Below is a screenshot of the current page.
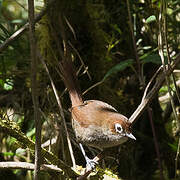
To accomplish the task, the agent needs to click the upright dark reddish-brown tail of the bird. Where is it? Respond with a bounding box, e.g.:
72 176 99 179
60 60 83 107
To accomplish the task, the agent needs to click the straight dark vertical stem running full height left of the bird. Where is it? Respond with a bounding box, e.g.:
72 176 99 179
28 0 42 180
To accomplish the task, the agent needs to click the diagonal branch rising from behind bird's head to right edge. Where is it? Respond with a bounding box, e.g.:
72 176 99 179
129 53 180 123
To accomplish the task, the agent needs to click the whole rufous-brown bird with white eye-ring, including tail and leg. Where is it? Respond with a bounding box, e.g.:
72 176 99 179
60 59 136 169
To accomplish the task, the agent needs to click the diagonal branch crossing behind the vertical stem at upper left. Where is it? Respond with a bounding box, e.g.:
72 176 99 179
0 0 56 53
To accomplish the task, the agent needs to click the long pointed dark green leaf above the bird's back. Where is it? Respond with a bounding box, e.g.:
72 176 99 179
103 59 133 81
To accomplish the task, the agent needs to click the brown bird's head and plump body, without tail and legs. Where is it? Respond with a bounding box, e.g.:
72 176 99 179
71 100 135 149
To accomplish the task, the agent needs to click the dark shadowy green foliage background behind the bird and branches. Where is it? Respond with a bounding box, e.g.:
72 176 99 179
0 0 180 180
